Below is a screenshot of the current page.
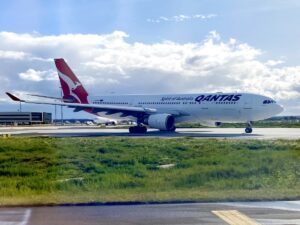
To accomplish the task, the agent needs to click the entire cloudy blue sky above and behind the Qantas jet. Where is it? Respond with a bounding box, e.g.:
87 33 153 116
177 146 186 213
0 0 300 118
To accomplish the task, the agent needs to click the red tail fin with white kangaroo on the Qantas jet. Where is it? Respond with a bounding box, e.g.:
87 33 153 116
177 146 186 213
54 59 88 103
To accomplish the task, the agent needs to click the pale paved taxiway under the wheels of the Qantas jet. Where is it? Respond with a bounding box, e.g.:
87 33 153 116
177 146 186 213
0 126 300 139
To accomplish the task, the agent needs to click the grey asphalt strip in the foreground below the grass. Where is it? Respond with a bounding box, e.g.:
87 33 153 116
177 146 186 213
0 201 300 225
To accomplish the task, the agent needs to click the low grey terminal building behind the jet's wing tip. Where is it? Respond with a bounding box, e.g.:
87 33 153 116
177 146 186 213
0 112 52 125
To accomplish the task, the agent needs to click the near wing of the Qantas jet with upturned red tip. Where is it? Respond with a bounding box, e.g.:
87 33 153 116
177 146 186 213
6 92 157 117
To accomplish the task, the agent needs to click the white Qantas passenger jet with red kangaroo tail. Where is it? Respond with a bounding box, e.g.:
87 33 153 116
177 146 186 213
6 58 283 133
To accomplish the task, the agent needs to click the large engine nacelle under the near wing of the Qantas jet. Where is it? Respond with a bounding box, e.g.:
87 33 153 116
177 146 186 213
145 113 175 130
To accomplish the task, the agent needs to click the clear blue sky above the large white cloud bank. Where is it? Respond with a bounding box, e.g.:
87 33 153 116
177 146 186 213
0 0 300 64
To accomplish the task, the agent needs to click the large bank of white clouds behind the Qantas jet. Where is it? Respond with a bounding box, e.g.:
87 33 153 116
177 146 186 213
0 31 300 114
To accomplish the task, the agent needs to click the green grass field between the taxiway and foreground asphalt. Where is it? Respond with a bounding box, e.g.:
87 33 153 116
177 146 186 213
0 137 300 205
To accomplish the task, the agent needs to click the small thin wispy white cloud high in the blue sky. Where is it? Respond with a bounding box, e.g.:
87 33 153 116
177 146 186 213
147 14 217 23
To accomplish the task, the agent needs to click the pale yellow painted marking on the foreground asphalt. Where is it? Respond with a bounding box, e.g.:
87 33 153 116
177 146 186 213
212 210 260 225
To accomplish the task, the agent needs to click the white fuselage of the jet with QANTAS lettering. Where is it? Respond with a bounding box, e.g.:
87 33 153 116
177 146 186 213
89 93 283 123
